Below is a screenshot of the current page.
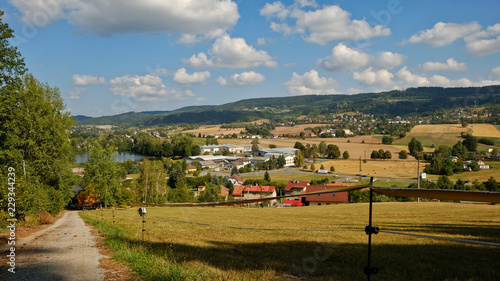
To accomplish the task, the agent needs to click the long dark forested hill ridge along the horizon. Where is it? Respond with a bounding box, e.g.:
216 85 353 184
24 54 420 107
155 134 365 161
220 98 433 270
78 86 500 126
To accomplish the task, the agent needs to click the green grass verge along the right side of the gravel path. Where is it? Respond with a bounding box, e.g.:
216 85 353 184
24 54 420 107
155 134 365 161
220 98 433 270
80 213 204 280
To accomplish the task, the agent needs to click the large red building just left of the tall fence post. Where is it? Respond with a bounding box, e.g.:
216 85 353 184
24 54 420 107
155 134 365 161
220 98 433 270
300 184 349 206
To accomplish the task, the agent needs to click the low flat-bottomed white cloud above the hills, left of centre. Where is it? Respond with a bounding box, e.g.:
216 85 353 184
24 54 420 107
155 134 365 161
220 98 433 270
109 74 193 101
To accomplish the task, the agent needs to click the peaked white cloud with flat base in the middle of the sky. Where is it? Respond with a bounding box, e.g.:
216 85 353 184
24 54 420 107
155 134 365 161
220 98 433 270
183 34 278 69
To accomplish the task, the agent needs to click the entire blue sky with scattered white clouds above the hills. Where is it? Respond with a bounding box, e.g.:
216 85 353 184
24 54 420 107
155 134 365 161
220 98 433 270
0 0 500 117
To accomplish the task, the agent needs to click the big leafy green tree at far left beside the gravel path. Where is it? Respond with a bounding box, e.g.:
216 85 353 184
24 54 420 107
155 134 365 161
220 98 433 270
0 74 77 216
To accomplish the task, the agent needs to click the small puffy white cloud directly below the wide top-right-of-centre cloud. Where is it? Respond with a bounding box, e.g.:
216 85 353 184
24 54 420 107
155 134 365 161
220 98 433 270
316 43 370 71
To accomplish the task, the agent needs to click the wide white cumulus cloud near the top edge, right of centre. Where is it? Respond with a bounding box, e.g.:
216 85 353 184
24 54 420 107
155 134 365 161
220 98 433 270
260 1 391 45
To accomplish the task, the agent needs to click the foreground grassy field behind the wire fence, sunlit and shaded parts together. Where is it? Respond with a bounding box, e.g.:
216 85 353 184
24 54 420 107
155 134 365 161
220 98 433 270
80 202 500 280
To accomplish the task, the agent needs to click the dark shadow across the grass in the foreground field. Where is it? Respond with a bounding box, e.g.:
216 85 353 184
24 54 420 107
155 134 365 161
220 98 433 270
115 236 500 280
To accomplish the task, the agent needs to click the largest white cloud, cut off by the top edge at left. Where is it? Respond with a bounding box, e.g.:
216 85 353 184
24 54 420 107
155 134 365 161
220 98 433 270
10 0 240 43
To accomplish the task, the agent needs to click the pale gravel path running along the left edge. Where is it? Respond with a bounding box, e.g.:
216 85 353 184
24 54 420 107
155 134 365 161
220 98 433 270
0 211 105 281
